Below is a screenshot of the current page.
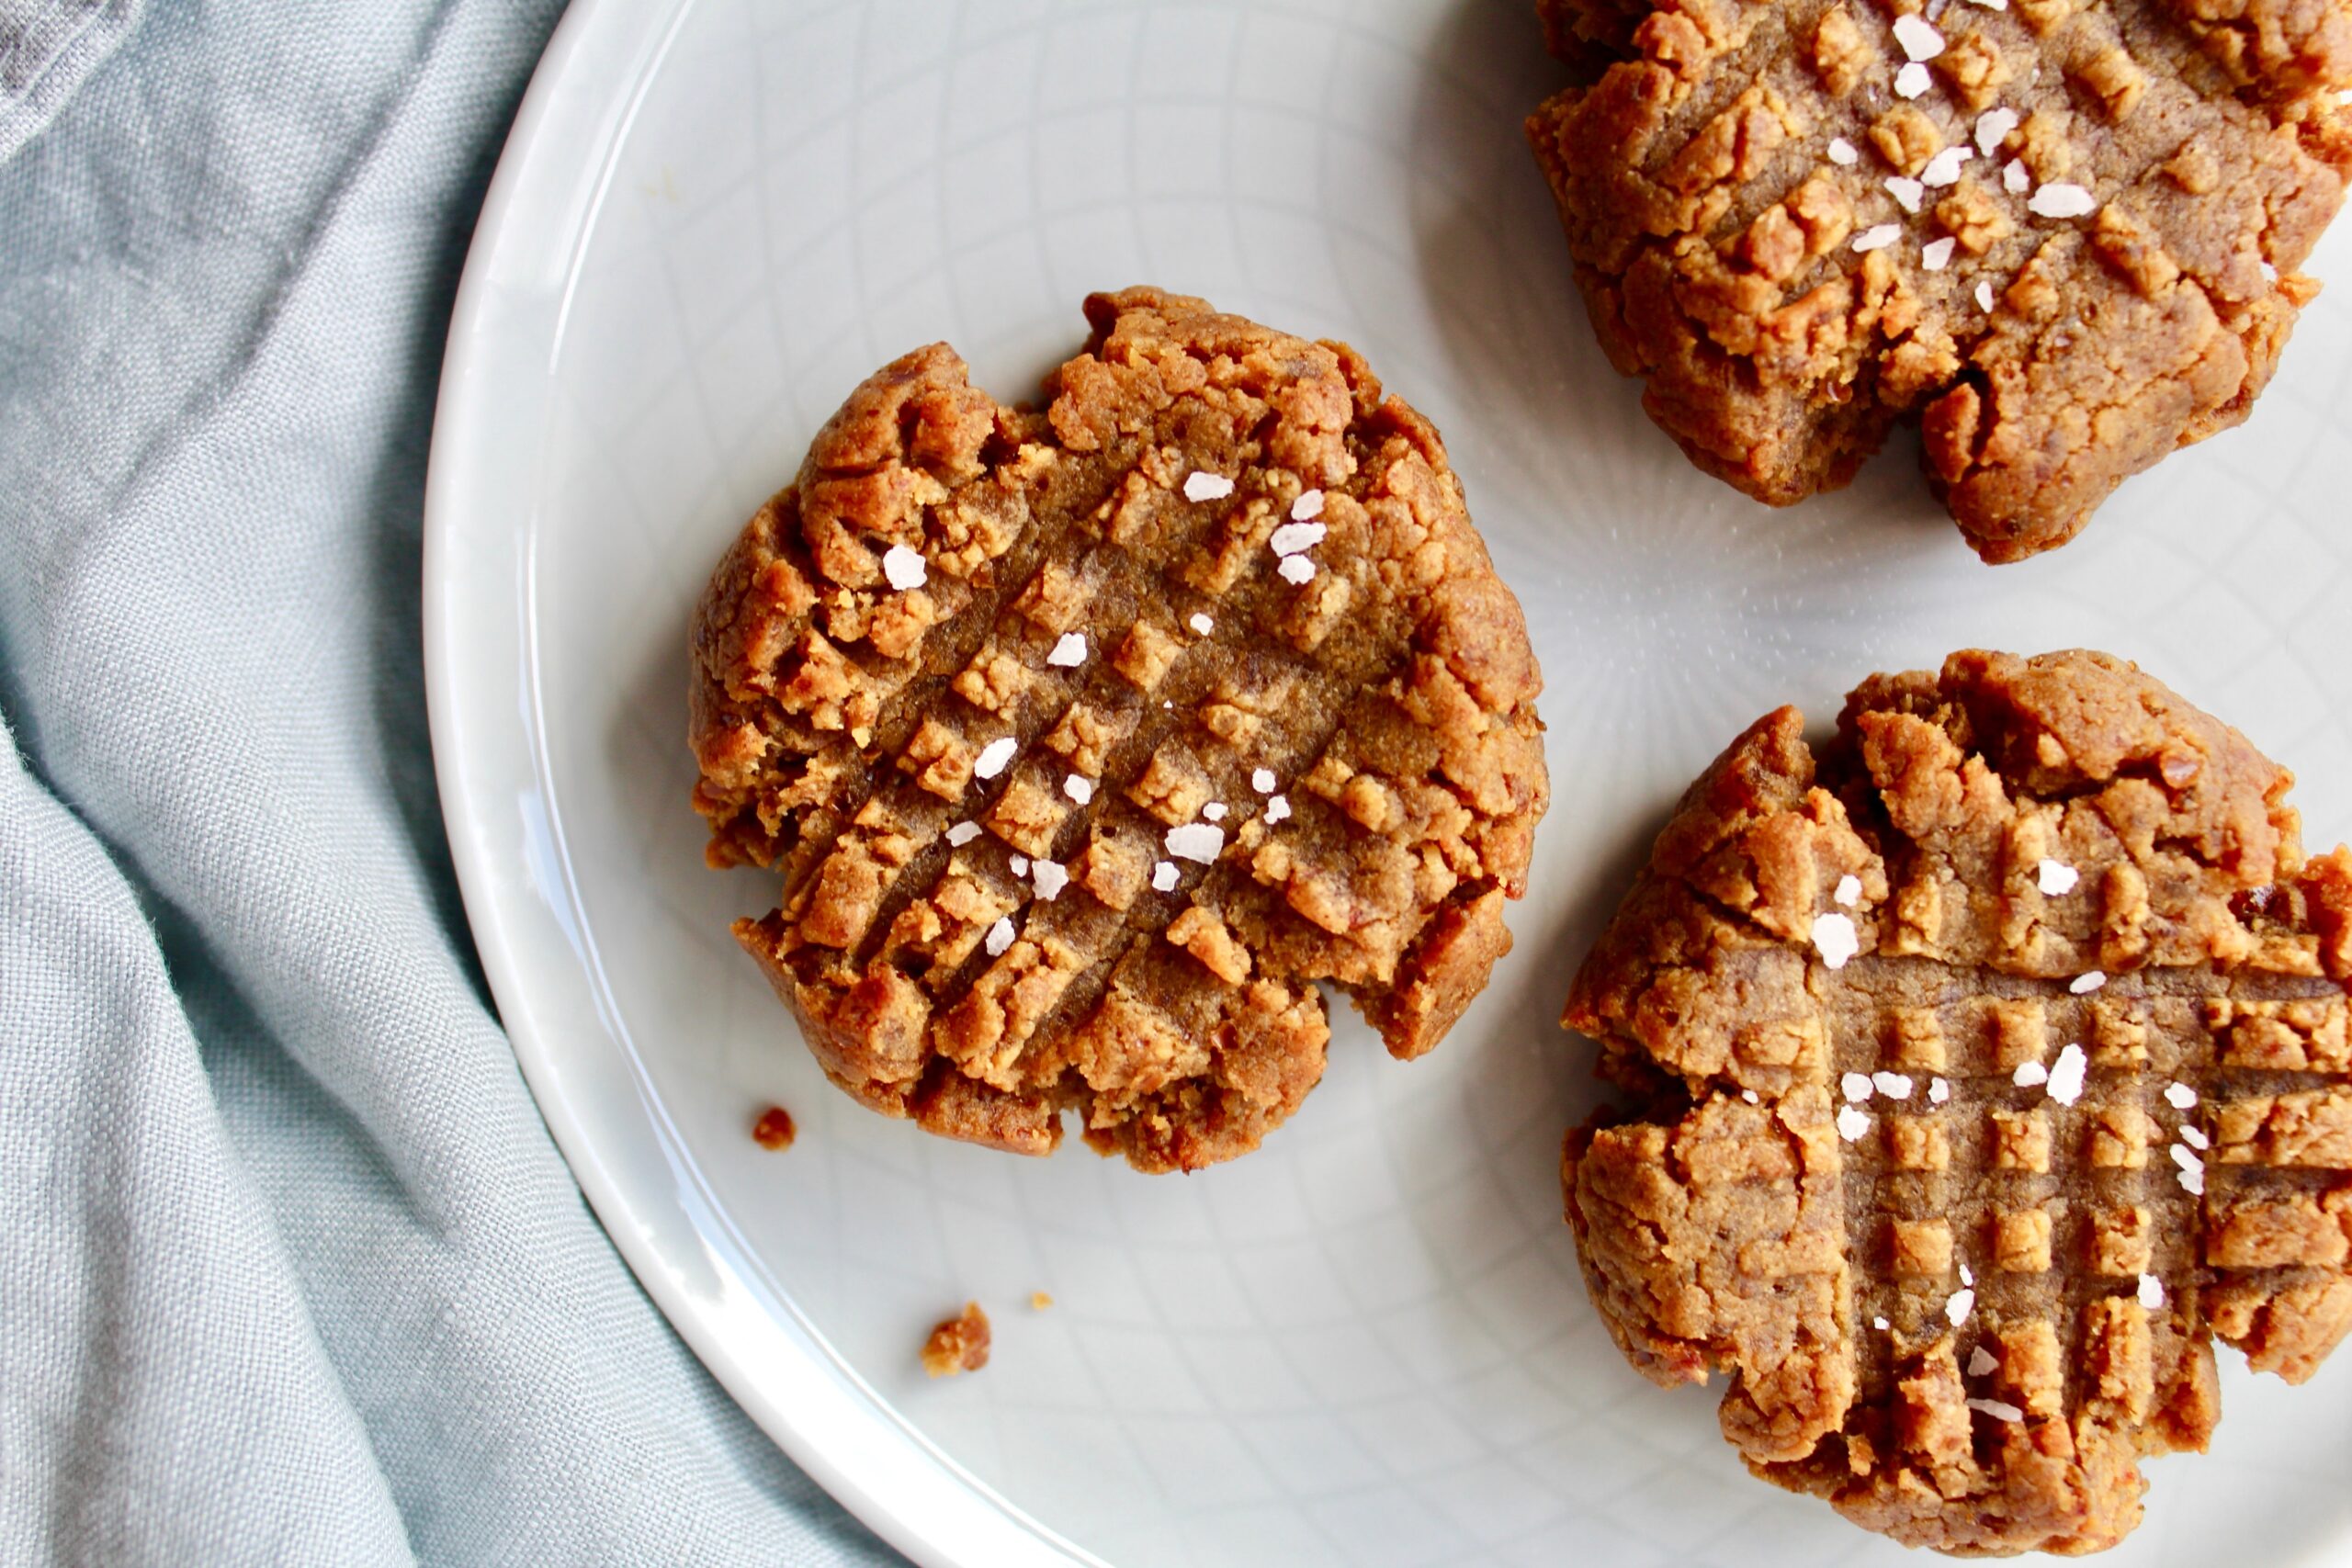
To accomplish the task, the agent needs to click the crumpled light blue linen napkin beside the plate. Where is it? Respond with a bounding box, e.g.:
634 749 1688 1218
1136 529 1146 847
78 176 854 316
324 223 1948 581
0 0 894 1568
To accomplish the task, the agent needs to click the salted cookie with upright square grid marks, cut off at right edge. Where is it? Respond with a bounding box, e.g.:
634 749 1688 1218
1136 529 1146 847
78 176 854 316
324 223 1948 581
1562 651 2352 1554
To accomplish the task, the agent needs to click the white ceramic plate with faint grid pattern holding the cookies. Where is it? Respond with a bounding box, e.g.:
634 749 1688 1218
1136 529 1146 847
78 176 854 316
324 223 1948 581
425 0 2352 1568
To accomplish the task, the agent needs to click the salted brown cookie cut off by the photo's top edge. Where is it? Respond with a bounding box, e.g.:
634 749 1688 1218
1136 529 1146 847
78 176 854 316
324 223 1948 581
1526 0 2352 562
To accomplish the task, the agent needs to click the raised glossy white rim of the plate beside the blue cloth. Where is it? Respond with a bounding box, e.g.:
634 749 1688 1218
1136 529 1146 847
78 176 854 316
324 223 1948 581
421 0 1108 1568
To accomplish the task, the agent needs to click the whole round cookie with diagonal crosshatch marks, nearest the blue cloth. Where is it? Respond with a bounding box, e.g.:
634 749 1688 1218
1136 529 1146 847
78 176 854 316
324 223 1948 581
692 289 1547 1170
